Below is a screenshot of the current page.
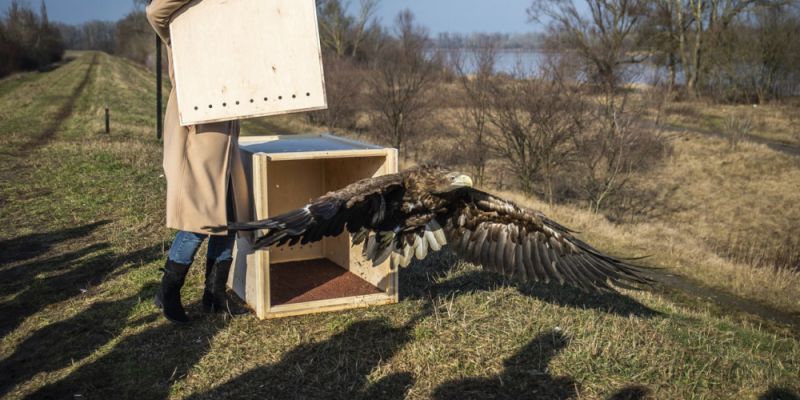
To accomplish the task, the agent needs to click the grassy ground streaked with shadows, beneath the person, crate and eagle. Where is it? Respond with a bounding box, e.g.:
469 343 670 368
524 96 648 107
0 53 800 399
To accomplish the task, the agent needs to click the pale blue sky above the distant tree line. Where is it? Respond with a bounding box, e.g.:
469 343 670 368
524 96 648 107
0 0 537 35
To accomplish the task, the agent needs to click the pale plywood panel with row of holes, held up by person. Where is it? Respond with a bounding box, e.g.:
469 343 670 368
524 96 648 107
170 0 327 125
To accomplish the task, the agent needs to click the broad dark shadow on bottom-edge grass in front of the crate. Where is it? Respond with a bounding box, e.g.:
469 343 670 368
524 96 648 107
187 314 430 400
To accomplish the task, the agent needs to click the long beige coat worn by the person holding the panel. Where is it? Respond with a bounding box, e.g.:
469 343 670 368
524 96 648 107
147 0 251 234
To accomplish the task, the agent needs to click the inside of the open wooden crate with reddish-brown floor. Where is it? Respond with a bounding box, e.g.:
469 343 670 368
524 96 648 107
267 156 388 306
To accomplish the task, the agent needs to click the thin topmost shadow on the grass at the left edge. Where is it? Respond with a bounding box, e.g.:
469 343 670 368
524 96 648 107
0 220 111 266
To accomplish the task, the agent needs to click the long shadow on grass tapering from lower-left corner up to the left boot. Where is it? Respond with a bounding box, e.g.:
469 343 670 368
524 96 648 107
0 283 156 397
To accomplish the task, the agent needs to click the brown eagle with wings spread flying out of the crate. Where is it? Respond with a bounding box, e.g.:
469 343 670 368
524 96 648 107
218 165 652 292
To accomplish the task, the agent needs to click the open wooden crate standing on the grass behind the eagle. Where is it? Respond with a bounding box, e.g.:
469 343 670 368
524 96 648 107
228 135 398 319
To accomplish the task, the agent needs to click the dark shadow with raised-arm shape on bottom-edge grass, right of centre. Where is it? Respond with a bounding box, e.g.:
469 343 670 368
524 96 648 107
433 331 577 400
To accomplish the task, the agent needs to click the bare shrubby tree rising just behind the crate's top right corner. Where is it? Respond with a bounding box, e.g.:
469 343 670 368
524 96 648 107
367 10 439 154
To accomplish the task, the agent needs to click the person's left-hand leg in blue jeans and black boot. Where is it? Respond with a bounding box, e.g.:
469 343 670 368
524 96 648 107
155 231 206 323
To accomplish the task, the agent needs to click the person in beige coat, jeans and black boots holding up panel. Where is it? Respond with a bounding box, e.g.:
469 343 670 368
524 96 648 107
145 0 251 323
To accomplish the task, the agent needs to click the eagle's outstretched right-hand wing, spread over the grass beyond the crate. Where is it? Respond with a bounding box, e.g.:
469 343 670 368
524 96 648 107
438 188 652 292
